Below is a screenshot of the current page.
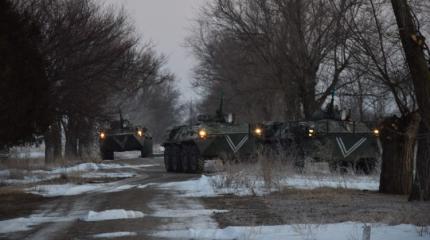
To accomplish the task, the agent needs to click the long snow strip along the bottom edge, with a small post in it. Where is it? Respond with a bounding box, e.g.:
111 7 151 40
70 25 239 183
153 222 430 240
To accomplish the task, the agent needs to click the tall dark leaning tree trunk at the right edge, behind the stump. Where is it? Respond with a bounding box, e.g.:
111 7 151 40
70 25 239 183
391 0 430 200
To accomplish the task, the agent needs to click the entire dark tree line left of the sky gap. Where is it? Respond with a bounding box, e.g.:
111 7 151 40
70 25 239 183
0 0 179 162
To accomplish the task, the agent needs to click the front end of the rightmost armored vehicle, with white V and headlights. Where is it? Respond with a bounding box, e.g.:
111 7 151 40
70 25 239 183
301 119 380 174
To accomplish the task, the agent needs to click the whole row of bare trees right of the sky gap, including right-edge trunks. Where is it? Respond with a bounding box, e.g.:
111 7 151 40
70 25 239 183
188 0 430 199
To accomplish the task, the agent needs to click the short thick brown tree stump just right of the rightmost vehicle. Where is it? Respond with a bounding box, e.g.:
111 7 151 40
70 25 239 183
379 112 420 194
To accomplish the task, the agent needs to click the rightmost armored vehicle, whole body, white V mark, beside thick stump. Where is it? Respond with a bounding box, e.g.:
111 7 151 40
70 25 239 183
260 95 380 174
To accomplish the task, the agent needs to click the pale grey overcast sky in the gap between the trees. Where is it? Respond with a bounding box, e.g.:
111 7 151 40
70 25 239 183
98 0 208 101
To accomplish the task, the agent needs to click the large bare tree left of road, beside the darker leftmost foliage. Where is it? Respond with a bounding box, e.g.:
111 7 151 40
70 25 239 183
21 0 173 160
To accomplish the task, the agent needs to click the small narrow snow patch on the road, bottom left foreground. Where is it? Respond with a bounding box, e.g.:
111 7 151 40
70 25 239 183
82 209 145 222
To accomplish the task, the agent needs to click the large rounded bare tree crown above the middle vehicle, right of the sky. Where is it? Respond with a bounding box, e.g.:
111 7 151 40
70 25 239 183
191 0 362 119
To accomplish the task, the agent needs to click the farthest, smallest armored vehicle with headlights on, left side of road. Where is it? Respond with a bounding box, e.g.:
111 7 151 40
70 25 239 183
99 113 152 160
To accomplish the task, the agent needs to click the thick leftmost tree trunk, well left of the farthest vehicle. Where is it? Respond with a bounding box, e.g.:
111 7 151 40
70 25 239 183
44 122 62 164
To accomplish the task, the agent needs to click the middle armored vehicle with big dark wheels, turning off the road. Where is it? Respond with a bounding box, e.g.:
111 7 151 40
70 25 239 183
163 98 261 173
